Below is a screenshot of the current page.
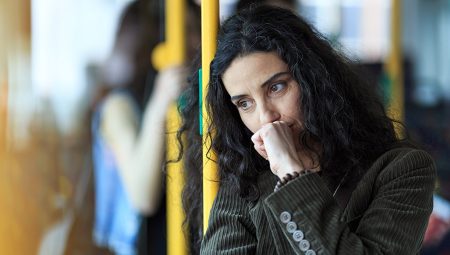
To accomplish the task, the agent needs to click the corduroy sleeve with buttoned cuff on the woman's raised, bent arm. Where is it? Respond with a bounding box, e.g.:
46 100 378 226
264 150 436 255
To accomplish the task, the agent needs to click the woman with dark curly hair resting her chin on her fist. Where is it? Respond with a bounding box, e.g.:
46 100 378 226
179 6 435 255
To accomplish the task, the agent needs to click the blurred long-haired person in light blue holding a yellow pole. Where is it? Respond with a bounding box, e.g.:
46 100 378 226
92 0 185 254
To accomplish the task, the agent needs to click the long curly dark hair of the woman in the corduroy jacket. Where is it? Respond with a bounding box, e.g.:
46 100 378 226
179 6 404 254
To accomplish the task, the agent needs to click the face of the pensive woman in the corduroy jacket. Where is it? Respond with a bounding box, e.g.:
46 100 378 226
222 52 303 141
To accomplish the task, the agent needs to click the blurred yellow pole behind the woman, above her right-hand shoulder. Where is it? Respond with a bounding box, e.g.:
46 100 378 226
385 0 404 133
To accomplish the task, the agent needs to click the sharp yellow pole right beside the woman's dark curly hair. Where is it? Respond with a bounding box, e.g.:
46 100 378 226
201 0 219 233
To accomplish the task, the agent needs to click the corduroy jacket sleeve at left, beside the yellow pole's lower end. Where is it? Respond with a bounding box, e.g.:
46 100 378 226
200 184 256 255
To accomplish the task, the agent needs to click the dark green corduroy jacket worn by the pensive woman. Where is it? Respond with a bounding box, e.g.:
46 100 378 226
200 148 436 255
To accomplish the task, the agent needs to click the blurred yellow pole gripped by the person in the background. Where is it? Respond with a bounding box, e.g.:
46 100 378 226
152 0 188 255
